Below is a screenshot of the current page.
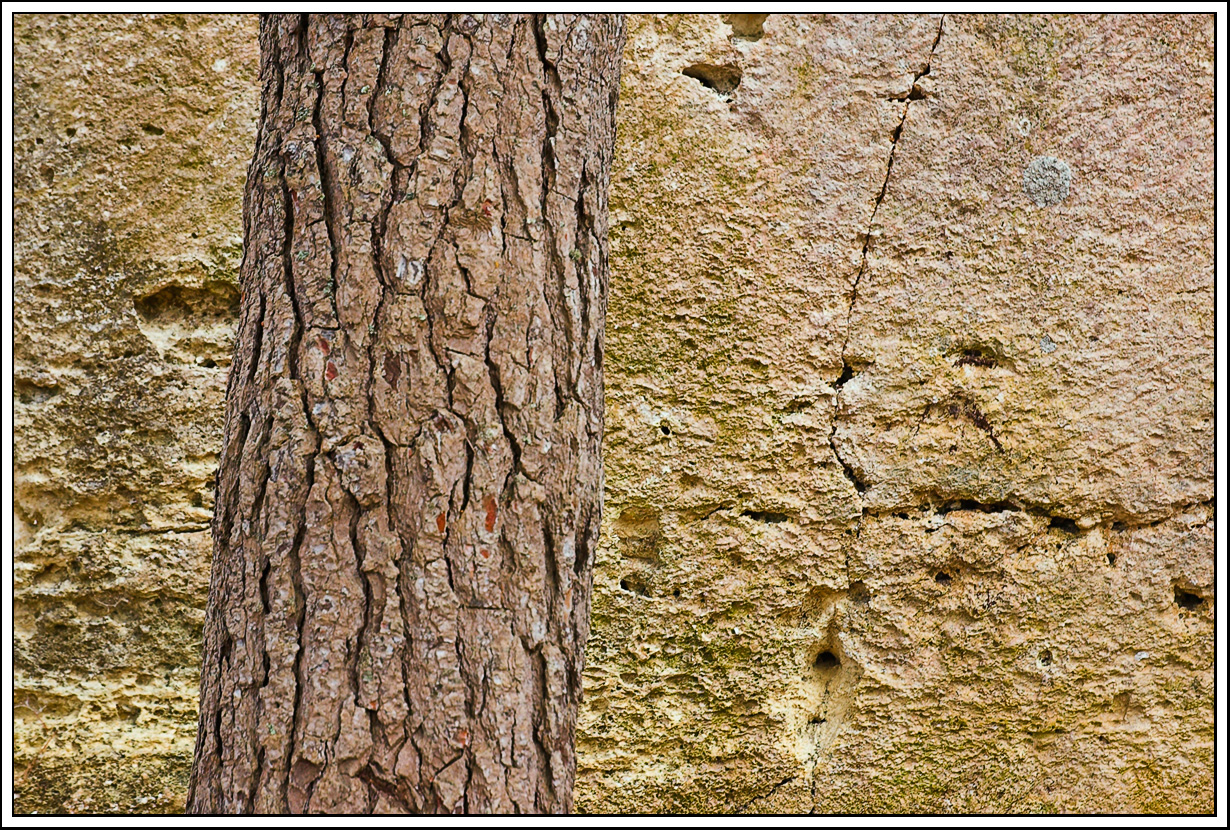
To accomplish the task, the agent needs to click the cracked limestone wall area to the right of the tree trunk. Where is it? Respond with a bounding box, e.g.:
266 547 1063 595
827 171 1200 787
578 15 1214 813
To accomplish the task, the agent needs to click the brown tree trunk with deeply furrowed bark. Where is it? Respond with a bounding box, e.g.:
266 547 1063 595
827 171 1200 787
188 15 624 813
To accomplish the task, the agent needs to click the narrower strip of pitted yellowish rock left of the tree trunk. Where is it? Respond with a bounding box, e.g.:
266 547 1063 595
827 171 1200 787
14 15 258 813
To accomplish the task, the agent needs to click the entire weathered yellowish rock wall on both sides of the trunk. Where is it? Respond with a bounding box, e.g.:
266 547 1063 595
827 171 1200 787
15 14 1214 812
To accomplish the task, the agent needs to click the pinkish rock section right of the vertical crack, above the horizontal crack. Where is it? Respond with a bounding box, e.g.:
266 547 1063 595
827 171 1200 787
836 16 1214 525
